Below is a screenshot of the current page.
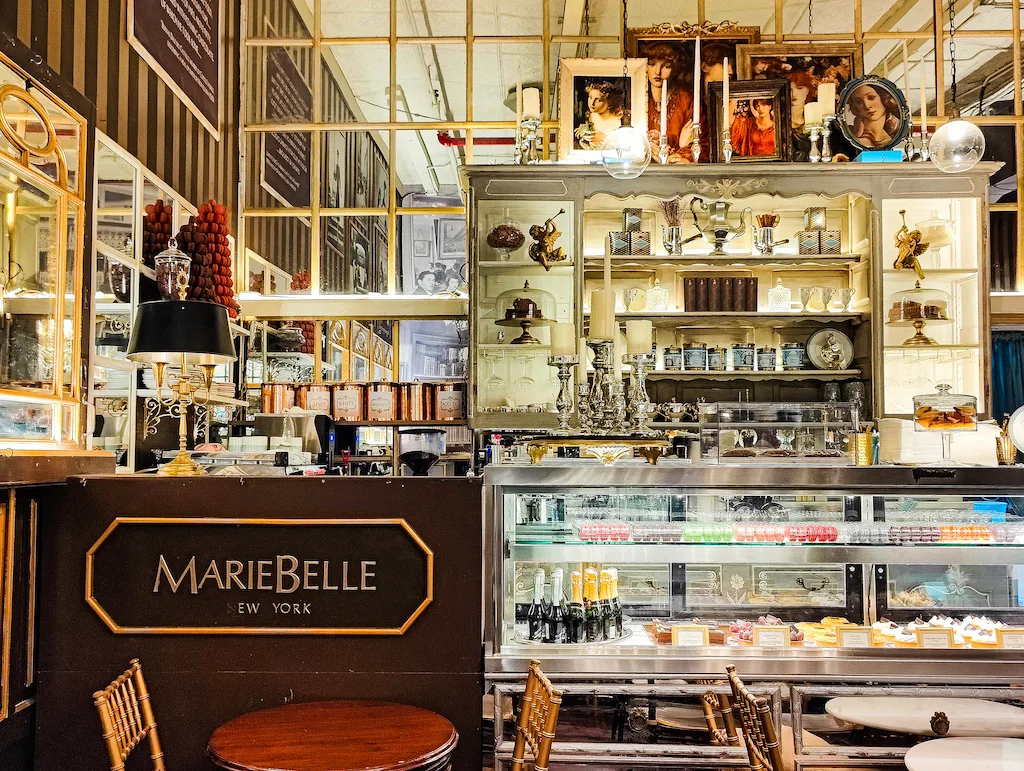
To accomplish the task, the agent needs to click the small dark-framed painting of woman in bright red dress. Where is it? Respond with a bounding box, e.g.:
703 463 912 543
709 78 790 163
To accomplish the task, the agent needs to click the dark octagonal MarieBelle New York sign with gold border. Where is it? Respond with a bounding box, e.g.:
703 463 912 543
86 517 433 635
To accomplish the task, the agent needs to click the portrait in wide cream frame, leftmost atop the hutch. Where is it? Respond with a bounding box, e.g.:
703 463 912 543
558 58 647 161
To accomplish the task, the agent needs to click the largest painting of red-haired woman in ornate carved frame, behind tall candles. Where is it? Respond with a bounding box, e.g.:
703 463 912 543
626 22 761 163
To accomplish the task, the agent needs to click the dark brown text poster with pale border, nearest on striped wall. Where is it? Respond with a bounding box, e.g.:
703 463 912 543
128 0 224 141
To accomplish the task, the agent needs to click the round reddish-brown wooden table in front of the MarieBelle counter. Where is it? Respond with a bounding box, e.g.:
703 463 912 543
208 701 459 771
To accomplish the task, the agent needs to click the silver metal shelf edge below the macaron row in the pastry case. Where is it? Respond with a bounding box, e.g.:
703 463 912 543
510 542 1024 565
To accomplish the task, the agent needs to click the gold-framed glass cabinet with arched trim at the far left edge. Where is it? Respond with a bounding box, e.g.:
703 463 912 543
0 52 87 451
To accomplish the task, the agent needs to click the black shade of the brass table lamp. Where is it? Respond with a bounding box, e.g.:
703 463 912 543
128 300 237 365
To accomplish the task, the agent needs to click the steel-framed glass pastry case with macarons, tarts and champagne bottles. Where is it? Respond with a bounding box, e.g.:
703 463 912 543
485 461 1024 676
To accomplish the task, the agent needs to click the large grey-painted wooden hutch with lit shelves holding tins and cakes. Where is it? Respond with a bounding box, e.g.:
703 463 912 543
462 163 997 429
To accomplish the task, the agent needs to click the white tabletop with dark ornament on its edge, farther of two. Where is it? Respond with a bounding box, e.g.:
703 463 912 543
825 696 1024 736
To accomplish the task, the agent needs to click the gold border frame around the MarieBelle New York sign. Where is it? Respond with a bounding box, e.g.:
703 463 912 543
85 517 434 637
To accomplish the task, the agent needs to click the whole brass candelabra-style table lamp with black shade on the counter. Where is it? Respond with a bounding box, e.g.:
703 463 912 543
128 300 237 476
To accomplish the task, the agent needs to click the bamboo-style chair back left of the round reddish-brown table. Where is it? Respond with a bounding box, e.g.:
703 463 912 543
92 658 167 771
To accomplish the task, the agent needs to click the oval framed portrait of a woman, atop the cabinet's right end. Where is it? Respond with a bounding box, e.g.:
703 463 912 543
836 75 910 149
